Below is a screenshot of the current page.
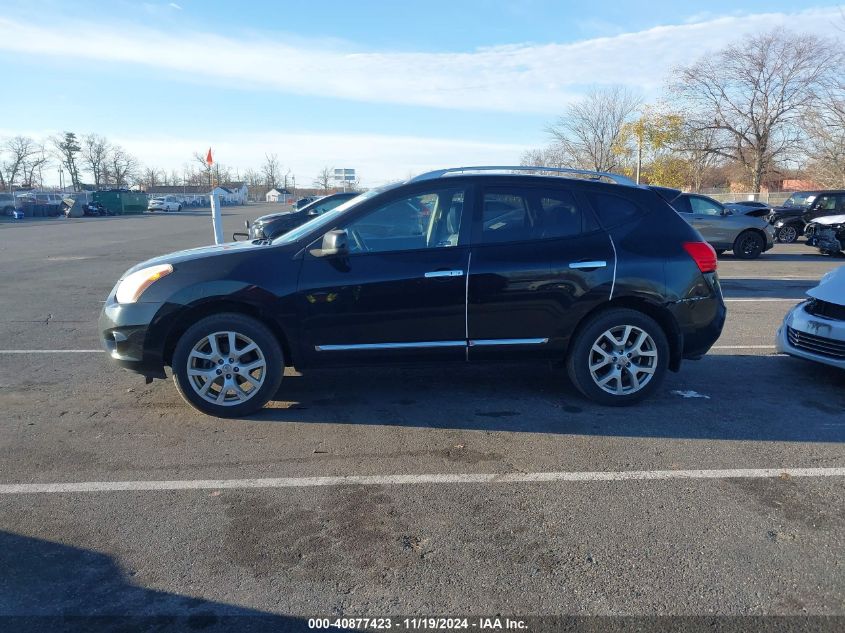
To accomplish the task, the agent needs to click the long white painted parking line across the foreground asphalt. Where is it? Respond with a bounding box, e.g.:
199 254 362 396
0 468 845 495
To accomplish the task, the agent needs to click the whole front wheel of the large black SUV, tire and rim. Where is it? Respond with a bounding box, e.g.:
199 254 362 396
173 313 284 418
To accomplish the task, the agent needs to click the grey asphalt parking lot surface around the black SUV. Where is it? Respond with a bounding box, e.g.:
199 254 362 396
0 205 845 630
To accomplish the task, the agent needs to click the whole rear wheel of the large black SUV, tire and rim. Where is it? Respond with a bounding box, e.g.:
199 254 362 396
566 308 669 406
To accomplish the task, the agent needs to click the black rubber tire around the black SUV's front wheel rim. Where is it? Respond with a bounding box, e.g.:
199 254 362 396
172 313 284 418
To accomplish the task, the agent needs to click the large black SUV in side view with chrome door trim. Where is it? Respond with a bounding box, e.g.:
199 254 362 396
100 167 726 417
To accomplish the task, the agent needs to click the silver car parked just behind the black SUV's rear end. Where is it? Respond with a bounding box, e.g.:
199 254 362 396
651 187 775 259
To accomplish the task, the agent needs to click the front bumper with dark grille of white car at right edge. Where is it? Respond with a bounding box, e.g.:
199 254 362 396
775 301 845 369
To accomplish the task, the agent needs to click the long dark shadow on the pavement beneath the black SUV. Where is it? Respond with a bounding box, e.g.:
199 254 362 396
248 355 845 442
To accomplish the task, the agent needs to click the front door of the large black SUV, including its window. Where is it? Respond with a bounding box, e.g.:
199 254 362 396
297 183 469 365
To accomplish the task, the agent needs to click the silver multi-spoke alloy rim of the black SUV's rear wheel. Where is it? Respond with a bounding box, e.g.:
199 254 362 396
587 325 658 396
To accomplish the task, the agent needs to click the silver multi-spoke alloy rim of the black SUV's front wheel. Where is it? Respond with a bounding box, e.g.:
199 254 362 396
187 331 267 407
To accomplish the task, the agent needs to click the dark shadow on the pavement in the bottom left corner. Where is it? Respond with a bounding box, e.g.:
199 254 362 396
0 531 308 633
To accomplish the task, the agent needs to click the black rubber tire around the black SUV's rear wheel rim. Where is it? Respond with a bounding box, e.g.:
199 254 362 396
566 308 669 406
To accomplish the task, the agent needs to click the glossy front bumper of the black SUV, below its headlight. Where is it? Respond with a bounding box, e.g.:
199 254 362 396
98 297 165 378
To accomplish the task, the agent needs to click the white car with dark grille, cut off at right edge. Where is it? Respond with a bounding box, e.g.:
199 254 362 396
776 266 845 369
